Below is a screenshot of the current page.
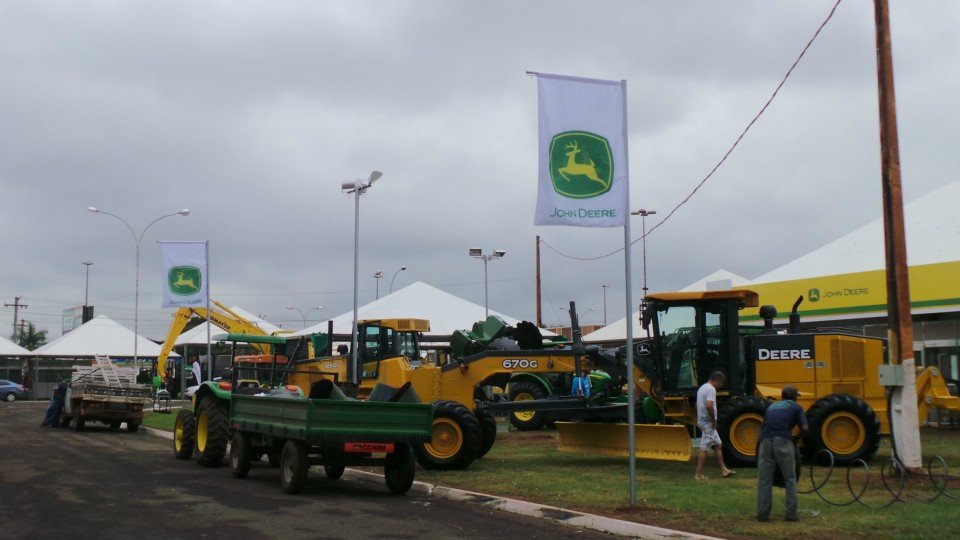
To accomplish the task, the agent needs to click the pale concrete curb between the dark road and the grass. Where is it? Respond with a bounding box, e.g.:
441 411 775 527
142 428 719 540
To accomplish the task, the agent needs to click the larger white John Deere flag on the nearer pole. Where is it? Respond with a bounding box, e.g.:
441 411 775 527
533 73 630 227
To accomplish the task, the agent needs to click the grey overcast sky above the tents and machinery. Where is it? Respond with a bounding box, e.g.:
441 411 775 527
0 0 960 339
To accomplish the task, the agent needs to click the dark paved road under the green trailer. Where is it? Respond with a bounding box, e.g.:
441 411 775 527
0 402 611 540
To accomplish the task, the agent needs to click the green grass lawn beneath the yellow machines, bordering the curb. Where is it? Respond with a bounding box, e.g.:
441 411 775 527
145 410 960 539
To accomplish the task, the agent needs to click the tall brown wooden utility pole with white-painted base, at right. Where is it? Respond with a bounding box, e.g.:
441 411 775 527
874 0 923 469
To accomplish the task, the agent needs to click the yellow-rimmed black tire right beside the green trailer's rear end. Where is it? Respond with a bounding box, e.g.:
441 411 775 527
414 401 482 471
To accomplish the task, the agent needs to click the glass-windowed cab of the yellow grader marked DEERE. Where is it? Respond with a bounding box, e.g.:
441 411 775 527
637 291 759 398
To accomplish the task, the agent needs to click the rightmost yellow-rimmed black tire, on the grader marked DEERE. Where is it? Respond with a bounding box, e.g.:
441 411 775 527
803 394 880 465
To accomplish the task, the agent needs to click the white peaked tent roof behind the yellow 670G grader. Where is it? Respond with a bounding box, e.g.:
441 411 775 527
292 281 555 336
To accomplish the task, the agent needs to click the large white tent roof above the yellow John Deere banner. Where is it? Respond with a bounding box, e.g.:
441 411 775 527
753 182 960 283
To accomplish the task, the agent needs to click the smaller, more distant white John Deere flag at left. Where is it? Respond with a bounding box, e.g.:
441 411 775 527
159 242 207 308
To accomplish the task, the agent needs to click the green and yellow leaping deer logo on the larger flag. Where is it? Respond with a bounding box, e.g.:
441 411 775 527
550 131 613 199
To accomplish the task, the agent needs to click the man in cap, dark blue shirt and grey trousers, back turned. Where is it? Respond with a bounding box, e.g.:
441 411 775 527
757 386 810 521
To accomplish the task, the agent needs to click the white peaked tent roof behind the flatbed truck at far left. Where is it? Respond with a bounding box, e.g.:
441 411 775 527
33 315 177 358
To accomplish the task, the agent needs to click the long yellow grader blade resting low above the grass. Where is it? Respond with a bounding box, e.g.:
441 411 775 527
556 422 692 461
